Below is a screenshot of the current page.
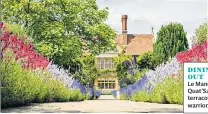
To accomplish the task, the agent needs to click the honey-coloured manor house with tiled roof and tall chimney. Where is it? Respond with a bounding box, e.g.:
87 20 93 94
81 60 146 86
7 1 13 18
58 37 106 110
94 15 154 92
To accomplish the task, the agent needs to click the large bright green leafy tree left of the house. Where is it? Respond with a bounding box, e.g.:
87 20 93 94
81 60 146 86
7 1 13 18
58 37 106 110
2 0 116 66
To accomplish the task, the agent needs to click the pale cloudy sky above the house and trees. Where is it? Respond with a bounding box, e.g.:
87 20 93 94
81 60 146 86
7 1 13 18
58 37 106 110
96 0 208 44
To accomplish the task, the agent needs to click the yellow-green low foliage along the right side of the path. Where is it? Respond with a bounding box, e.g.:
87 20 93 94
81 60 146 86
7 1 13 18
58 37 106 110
131 75 183 104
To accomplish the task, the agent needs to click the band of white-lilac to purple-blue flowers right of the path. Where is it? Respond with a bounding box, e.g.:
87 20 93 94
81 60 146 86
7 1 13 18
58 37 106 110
120 58 180 97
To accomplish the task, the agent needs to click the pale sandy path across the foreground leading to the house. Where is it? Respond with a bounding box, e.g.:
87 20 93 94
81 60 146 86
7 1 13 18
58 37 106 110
1 96 183 113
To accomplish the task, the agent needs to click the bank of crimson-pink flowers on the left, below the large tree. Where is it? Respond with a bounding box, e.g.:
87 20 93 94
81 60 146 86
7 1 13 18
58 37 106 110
0 23 49 69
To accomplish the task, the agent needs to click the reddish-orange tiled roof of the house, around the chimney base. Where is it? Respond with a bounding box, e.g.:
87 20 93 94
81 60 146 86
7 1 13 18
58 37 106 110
116 34 154 55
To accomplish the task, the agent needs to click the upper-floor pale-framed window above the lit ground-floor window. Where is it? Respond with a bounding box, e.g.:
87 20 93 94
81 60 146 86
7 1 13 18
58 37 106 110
98 59 113 69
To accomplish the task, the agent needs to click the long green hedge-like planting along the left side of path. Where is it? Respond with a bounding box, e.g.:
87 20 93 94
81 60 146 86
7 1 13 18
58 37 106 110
1 51 84 108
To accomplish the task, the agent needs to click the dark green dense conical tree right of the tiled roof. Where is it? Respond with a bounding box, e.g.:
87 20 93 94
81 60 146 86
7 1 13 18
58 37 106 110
153 23 188 64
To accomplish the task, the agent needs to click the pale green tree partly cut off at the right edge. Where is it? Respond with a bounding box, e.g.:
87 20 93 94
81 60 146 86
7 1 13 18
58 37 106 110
195 21 207 44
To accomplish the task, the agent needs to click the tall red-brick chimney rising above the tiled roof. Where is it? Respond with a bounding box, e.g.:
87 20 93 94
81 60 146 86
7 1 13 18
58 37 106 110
121 15 128 45
